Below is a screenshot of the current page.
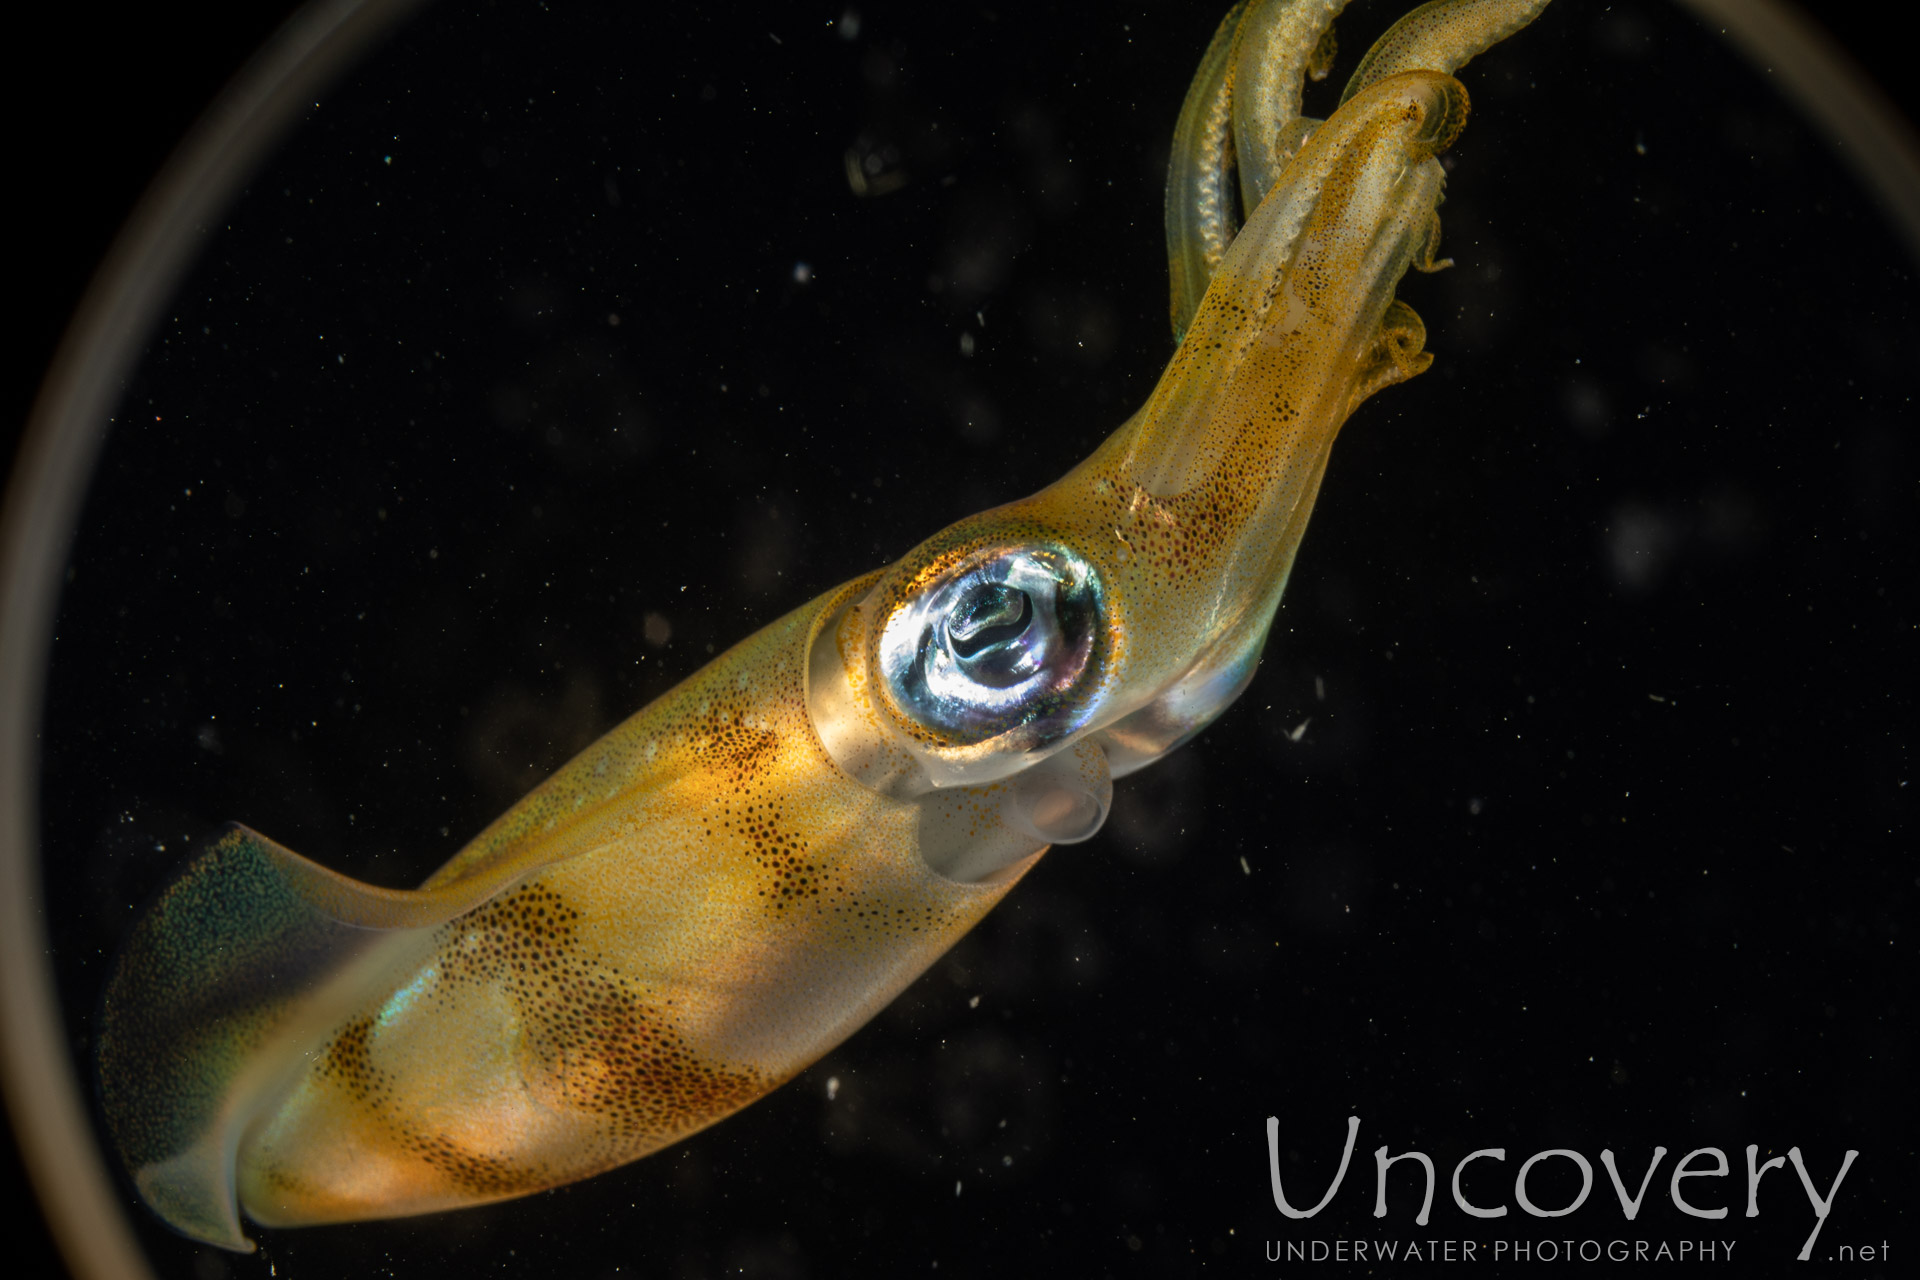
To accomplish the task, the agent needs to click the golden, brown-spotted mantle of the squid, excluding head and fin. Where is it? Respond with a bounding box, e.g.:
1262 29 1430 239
238 579 1023 1224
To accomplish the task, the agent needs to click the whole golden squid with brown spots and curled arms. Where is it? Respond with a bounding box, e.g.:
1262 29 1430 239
98 0 1546 1249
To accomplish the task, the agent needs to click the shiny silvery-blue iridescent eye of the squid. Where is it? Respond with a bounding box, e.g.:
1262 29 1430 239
879 547 1100 747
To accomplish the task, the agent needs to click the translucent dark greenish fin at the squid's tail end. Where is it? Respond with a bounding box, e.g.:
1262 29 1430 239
100 825 524 1249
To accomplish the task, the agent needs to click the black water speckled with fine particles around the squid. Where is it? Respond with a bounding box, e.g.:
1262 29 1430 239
8 0 1916 1276
